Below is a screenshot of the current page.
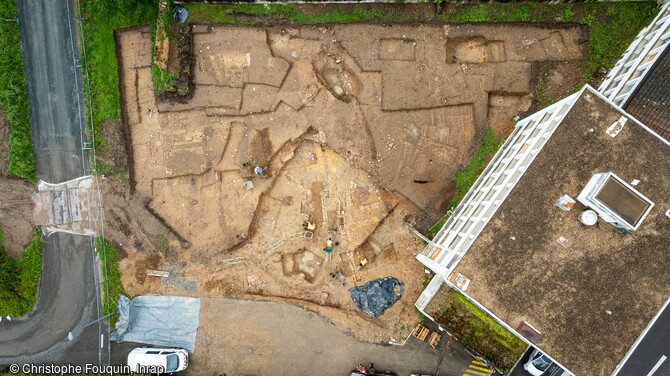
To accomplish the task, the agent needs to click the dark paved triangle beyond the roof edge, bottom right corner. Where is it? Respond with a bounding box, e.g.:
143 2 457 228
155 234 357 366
616 305 670 376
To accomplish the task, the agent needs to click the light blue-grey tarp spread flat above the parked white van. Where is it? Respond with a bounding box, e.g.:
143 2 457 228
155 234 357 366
111 295 200 352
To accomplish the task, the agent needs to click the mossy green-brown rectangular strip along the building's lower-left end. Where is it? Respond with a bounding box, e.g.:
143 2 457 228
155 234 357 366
428 290 527 371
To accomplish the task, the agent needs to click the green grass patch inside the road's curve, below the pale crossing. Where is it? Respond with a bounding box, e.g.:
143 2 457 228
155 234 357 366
0 230 42 317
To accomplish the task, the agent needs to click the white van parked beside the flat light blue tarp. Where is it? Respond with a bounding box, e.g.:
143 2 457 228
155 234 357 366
128 347 188 373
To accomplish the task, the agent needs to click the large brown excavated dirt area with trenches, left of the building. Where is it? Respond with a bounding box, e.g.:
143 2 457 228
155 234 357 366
104 24 586 342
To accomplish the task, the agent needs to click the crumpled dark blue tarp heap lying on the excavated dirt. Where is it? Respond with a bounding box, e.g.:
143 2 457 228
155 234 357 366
349 277 405 318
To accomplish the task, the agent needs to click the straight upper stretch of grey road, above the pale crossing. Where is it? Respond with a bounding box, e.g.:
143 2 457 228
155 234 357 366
18 0 87 183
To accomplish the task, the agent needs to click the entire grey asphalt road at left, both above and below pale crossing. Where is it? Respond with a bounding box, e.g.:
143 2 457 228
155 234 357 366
0 0 105 364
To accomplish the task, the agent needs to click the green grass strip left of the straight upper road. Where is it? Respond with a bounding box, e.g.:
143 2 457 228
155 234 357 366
0 0 35 182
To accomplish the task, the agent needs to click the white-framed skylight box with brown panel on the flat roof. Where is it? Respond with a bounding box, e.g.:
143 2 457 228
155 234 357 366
577 172 654 233
